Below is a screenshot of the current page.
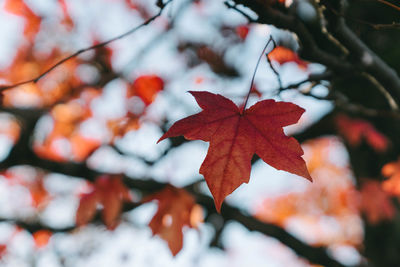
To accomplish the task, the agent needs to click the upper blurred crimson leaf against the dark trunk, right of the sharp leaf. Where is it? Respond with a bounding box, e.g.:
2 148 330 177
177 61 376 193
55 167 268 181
335 114 389 152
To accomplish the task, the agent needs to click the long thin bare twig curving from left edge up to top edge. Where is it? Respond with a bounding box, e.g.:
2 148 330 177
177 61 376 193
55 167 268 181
0 0 173 92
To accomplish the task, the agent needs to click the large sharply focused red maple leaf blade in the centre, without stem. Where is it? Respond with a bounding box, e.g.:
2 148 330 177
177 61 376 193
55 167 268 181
158 92 311 211
